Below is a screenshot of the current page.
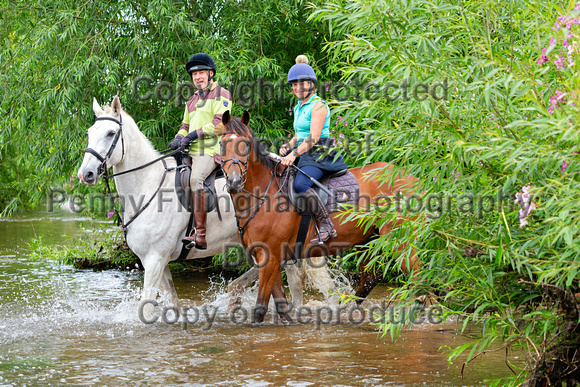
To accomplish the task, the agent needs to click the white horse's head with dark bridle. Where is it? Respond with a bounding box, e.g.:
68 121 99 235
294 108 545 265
78 96 125 185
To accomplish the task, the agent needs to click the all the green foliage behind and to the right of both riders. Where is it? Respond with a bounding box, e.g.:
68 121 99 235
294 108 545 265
0 0 580 384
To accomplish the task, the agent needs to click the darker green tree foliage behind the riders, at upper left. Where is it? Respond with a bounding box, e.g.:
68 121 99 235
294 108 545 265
0 0 340 215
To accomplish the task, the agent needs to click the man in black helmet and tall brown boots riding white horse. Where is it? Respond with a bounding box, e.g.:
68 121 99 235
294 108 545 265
169 52 232 249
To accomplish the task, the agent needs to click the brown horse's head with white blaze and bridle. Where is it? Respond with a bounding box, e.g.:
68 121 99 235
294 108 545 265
220 111 254 193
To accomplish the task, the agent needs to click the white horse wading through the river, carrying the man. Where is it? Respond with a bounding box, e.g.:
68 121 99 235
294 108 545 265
78 97 335 308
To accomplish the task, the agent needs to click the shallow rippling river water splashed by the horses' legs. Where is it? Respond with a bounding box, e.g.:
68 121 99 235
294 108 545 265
0 212 517 386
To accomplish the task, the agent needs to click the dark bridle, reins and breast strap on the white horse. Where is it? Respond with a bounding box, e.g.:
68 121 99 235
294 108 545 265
85 115 180 239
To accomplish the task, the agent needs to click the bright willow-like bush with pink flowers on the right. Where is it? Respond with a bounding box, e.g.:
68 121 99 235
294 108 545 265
312 0 580 383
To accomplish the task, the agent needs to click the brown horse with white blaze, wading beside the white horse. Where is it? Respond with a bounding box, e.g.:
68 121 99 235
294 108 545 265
221 112 418 322
